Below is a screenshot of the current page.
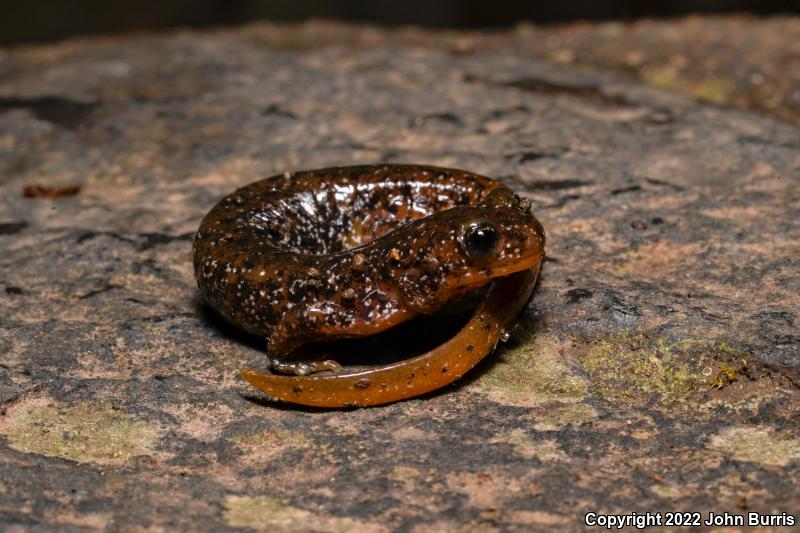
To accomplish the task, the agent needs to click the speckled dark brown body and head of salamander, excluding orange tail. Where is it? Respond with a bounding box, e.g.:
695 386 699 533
194 165 544 373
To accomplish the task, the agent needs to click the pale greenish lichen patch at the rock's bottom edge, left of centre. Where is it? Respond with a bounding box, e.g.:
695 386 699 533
224 495 387 533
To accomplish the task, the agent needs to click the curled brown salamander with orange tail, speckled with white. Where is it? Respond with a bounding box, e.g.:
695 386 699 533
194 165 545 407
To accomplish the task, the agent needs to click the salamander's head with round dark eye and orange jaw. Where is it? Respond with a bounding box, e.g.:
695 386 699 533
389 189 545 313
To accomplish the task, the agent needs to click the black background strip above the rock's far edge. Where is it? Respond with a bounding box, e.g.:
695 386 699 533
0 0 800 45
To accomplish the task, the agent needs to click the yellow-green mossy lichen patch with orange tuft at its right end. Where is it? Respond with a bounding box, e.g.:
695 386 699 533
581 333 769 403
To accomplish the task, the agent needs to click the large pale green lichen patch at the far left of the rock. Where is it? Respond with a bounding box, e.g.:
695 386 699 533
0 400 158 463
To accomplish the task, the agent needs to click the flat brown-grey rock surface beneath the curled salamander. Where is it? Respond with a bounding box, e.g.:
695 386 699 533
0 17 800 532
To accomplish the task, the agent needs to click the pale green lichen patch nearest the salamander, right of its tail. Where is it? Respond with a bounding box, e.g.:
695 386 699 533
479 332 588 407
